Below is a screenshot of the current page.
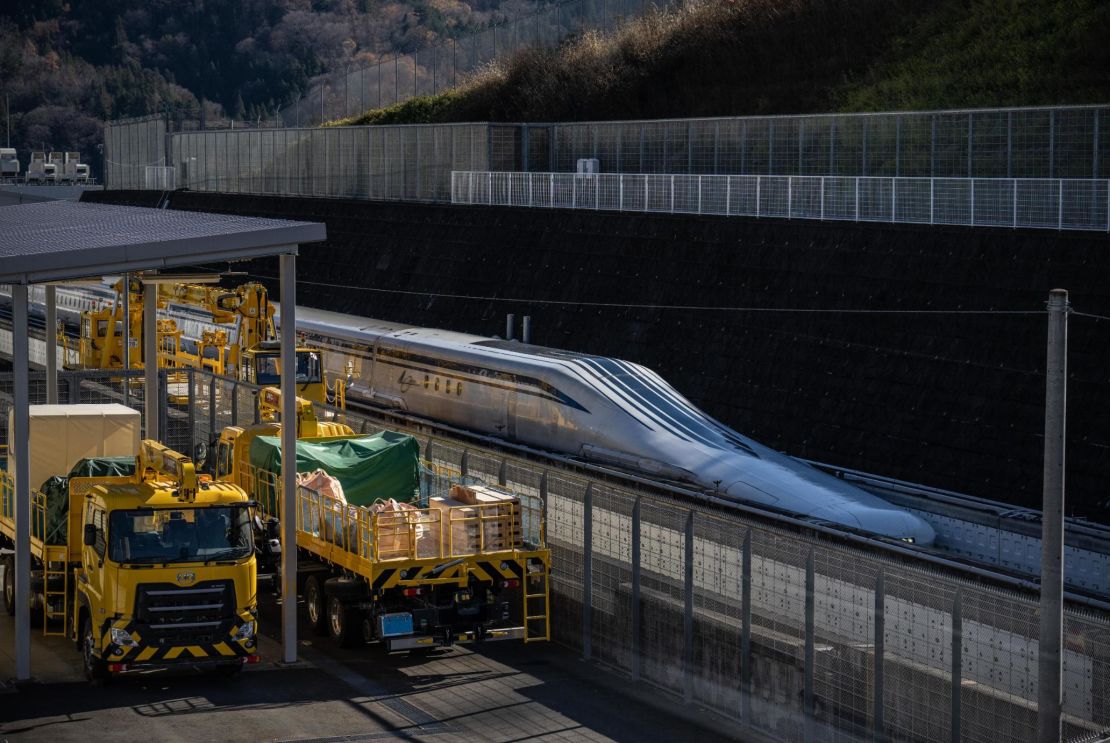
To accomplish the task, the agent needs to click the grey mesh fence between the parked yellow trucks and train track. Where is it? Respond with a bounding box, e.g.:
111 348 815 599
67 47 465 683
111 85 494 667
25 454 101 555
0 371 1110 741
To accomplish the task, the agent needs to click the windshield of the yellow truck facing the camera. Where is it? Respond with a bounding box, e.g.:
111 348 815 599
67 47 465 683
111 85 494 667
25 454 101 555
108 505 254 563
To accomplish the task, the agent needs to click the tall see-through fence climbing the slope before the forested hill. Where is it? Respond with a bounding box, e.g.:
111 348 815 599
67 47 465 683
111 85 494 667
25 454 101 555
280 0 675 127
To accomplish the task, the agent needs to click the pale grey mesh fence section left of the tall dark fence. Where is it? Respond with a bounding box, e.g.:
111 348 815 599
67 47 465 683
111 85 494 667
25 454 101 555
172 123 488 201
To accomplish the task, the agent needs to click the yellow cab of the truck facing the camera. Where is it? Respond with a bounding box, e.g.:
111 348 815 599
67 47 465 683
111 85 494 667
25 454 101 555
70 441 259 682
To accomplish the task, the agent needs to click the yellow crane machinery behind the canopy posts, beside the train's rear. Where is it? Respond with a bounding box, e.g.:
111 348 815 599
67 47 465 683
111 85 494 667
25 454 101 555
77 278 346 408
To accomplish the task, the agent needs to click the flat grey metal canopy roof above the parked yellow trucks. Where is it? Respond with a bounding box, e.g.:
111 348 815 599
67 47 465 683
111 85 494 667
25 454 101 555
0 201 327 284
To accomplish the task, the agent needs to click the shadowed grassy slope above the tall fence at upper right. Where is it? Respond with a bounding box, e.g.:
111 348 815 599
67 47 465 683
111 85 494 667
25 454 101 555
336 0 1110 123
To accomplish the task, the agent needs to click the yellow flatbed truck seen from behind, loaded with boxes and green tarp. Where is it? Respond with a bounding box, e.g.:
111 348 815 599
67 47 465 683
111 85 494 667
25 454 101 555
209 390 551 651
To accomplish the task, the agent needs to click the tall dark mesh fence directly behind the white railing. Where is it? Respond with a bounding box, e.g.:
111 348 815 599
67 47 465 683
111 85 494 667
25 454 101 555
546 106 1110 179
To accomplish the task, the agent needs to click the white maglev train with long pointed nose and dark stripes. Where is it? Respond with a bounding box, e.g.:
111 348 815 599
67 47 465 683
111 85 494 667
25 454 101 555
288 307 936 545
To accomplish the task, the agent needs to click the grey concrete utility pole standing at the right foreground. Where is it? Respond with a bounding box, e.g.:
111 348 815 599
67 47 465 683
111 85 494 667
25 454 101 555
1037 289 1069 743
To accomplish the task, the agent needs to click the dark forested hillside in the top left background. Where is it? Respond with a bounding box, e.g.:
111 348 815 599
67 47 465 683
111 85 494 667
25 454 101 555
0 0 538 162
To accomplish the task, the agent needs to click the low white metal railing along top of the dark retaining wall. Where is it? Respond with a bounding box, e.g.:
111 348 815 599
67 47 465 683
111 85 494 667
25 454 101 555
451 171 1110 231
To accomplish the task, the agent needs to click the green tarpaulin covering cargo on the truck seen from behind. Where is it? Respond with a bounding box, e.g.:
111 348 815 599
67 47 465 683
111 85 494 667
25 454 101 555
251 431 420 505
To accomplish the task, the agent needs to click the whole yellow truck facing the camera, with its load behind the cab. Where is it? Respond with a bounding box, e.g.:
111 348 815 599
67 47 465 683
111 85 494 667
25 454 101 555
0 405 259 683
